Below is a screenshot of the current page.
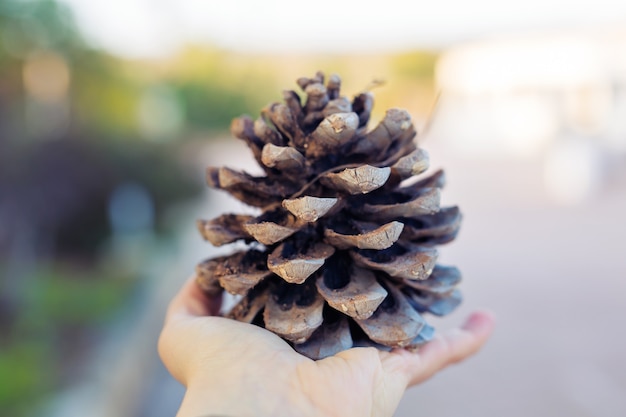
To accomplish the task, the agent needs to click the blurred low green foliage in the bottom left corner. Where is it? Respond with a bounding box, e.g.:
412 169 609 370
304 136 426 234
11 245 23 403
0 264 137 417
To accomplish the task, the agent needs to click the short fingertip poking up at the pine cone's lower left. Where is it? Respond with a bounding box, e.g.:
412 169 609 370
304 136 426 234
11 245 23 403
165 276 222 322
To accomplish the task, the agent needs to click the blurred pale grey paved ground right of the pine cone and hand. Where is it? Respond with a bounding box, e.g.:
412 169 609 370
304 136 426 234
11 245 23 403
397 146 626 417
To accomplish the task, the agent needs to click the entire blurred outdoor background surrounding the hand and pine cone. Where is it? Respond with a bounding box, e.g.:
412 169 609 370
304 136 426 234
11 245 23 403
0 0 626 417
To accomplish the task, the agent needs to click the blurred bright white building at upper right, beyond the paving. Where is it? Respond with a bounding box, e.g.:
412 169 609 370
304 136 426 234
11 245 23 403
431 28 626 202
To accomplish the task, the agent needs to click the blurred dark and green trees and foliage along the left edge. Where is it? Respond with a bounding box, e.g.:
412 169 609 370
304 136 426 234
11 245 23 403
0 4 201 417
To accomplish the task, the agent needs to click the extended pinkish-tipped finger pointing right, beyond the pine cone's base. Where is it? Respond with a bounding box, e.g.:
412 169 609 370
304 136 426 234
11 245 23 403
405 311 495 385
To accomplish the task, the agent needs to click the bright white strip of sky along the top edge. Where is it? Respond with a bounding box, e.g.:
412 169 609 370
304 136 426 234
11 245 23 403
62 0 626 57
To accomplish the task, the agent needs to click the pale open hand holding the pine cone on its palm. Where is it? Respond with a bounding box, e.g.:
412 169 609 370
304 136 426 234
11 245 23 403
159 280 494 417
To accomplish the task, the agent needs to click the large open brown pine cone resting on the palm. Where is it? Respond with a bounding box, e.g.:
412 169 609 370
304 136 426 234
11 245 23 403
196 72 461 359
